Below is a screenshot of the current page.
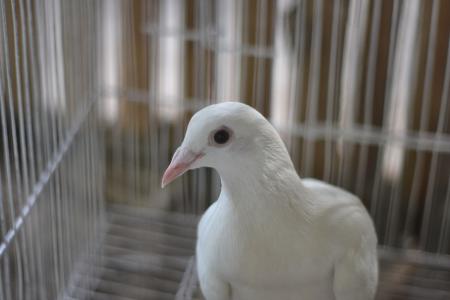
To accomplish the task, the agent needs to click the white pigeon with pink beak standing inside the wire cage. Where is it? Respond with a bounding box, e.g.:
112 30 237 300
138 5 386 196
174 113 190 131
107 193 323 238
162 102 378 300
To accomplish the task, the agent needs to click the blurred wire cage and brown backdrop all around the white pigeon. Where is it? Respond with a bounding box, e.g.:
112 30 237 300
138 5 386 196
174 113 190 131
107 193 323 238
0 0 450 300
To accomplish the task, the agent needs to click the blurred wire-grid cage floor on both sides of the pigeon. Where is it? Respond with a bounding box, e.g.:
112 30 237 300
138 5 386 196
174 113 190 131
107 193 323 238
69 205 450 300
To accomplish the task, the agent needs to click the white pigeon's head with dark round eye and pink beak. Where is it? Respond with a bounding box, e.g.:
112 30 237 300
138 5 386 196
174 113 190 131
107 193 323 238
161 102 287 187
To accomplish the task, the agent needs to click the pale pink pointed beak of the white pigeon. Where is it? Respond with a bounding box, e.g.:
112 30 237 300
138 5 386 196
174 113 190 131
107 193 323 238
161 147 205 188
